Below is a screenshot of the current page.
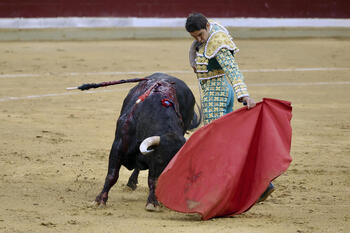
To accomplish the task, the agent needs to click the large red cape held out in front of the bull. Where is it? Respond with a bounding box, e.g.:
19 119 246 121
156 98 292 220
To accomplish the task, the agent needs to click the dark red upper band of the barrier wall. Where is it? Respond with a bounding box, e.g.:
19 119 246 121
0 0 350 18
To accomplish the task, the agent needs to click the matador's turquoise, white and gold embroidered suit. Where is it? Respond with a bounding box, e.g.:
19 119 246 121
190 21 249 124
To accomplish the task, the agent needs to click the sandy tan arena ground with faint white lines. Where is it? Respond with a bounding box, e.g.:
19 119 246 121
0 39 350 233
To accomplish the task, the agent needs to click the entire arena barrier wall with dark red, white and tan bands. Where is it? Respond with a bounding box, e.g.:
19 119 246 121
0 0 350 40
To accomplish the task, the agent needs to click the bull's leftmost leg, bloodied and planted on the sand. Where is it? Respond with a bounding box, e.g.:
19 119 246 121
95 142 121 206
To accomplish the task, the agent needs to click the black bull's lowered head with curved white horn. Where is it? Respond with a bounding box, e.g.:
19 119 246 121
140 133 186 178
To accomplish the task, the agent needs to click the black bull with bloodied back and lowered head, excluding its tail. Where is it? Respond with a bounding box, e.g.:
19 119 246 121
95 73 201 210
